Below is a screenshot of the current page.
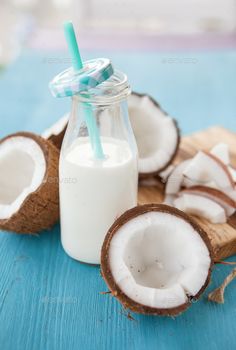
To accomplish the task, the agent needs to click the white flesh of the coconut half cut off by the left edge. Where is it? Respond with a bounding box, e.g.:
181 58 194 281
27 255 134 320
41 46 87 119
0 136 46 219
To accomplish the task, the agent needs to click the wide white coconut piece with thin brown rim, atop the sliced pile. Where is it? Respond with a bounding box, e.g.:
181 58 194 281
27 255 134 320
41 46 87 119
183 151 234 190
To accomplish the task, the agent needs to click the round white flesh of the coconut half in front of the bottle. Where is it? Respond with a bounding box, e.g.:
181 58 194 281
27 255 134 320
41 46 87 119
109 212 211 309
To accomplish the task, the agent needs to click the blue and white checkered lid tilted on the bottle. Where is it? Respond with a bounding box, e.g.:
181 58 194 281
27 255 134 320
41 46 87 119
49 58 114 97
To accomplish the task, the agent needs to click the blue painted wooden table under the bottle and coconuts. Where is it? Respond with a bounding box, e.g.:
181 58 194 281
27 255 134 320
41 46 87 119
0 51 236 350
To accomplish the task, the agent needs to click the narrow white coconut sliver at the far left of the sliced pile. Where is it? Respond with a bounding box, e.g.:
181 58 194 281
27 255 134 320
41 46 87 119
165 159 191 195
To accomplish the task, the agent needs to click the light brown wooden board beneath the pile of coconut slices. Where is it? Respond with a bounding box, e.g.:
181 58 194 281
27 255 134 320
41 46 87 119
139 127 236 260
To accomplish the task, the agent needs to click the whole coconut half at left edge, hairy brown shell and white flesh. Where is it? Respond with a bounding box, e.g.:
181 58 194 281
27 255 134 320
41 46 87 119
0 132 59 233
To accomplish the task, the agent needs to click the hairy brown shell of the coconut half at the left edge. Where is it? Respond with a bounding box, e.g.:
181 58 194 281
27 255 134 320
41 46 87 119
0 132 59 233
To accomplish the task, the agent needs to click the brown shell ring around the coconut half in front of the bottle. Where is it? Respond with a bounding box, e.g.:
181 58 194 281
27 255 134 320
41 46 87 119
101 204 213 316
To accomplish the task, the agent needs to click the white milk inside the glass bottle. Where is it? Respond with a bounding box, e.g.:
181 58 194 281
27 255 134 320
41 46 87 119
60 138 138 264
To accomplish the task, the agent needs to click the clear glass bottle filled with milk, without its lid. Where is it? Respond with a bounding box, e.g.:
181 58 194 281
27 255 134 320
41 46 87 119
60 71 138 264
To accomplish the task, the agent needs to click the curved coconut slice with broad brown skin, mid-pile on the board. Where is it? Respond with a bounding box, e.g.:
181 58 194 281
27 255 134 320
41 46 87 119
180 186 236 216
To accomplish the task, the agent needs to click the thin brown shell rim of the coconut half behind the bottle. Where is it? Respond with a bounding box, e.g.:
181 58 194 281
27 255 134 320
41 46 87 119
132 91 181 180
